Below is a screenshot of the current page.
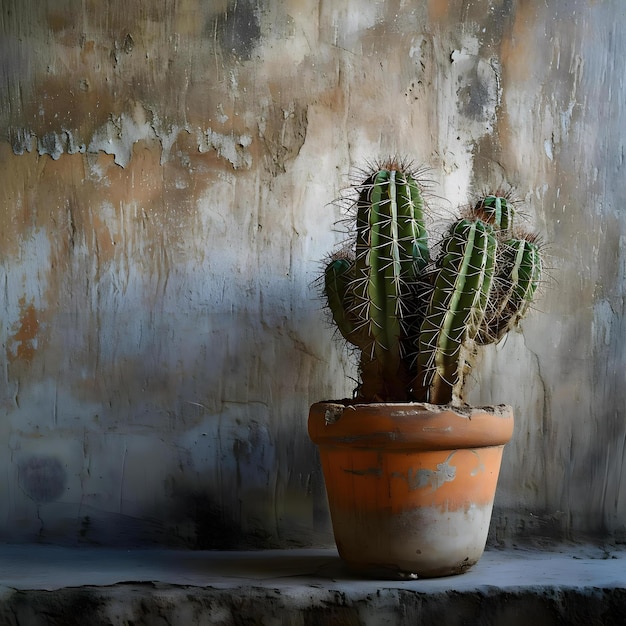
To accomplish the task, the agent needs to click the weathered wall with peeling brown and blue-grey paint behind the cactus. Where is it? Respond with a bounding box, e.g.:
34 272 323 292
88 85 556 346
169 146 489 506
0 0 626 548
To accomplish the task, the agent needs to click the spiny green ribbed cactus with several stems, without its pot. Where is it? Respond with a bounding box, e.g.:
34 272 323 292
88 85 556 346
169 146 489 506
324 159 542 404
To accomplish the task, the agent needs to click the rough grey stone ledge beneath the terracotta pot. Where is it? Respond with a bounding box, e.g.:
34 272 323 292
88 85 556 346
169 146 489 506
0 545 626 626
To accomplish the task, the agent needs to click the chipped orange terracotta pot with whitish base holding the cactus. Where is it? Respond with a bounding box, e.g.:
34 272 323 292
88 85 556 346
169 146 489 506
309 402 513 578
